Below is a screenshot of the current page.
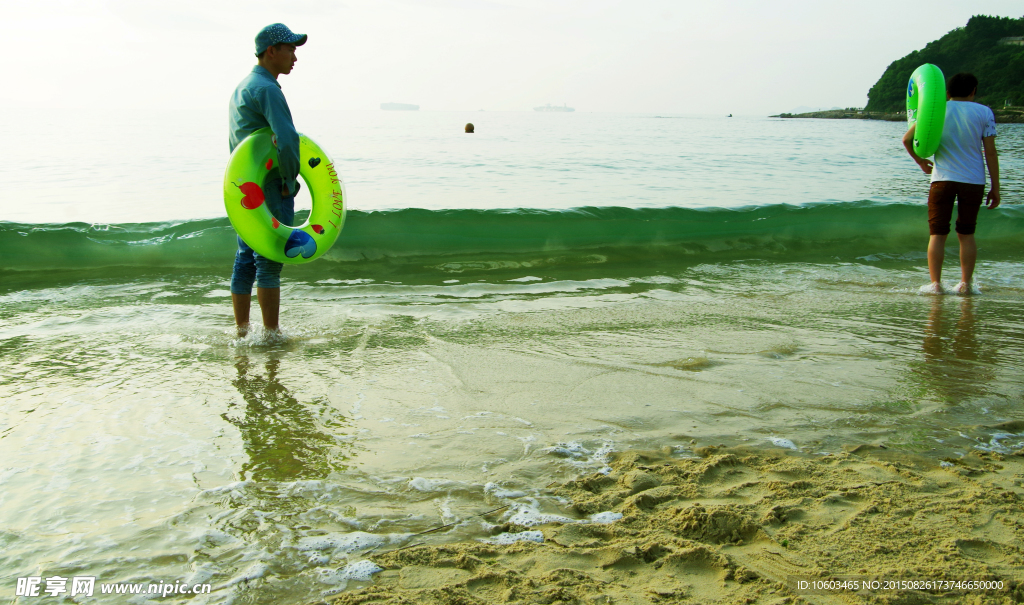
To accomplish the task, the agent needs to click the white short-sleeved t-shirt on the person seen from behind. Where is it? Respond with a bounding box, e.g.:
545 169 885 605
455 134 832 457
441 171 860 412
932 100 995 185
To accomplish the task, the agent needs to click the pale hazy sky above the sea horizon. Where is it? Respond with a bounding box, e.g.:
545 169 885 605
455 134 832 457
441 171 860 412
0 0 1024 115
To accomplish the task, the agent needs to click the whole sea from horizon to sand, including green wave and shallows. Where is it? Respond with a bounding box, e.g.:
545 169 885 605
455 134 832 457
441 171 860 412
0 112 1024 603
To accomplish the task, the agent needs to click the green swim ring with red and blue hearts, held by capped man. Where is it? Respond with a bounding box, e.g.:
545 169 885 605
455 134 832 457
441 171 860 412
224 128 346 264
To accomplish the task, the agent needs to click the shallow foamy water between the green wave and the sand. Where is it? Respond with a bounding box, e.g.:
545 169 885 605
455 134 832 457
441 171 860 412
0 254 1024 603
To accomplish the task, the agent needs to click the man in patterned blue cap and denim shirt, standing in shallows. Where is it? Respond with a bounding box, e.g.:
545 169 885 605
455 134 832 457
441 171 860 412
227 24 306 337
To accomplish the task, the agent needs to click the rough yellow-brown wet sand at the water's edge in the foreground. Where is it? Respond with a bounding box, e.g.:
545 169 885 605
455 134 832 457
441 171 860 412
327 442 1024 605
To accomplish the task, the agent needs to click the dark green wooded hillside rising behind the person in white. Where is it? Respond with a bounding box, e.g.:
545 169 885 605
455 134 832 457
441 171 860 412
864 14 1024 112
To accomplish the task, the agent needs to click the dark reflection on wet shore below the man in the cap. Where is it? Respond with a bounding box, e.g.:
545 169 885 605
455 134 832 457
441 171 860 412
221 355 352 481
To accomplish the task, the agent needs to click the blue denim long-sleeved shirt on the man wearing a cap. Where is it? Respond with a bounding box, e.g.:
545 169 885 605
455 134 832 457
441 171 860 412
227 66 299 196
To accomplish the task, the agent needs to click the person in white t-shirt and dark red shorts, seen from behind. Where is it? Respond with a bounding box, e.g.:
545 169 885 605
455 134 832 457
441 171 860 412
903 73 999 294
